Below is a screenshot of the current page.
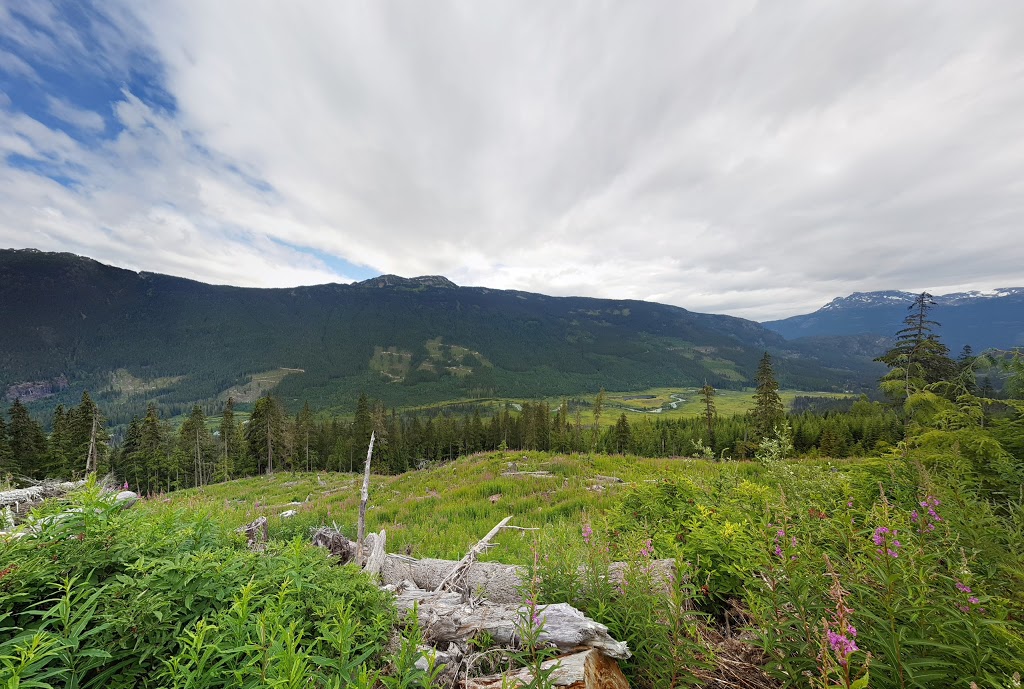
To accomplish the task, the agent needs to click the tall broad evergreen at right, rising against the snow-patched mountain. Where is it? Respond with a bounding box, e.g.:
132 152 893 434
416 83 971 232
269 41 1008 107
876 292 956 398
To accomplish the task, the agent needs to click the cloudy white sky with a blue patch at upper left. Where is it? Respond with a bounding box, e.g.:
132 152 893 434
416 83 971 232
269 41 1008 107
0 0 1024 320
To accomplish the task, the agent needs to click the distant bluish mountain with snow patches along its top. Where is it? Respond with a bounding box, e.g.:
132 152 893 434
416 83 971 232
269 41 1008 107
762 288 1024 354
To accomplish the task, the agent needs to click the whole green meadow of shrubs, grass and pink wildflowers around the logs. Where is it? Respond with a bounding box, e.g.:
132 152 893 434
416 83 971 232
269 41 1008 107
0 403 1024 689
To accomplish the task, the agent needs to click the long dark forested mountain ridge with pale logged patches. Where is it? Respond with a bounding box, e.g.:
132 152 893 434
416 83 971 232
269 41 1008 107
0 250 873 412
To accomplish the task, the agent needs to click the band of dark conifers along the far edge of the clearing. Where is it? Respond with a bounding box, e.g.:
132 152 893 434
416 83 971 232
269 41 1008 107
0 293 1024 492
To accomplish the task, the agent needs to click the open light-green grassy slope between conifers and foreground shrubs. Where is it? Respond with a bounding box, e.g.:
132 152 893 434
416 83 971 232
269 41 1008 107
149 453 839 563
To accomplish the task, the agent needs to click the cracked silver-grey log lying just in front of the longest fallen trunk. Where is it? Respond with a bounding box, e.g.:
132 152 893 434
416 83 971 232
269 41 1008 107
395 589 630 658
